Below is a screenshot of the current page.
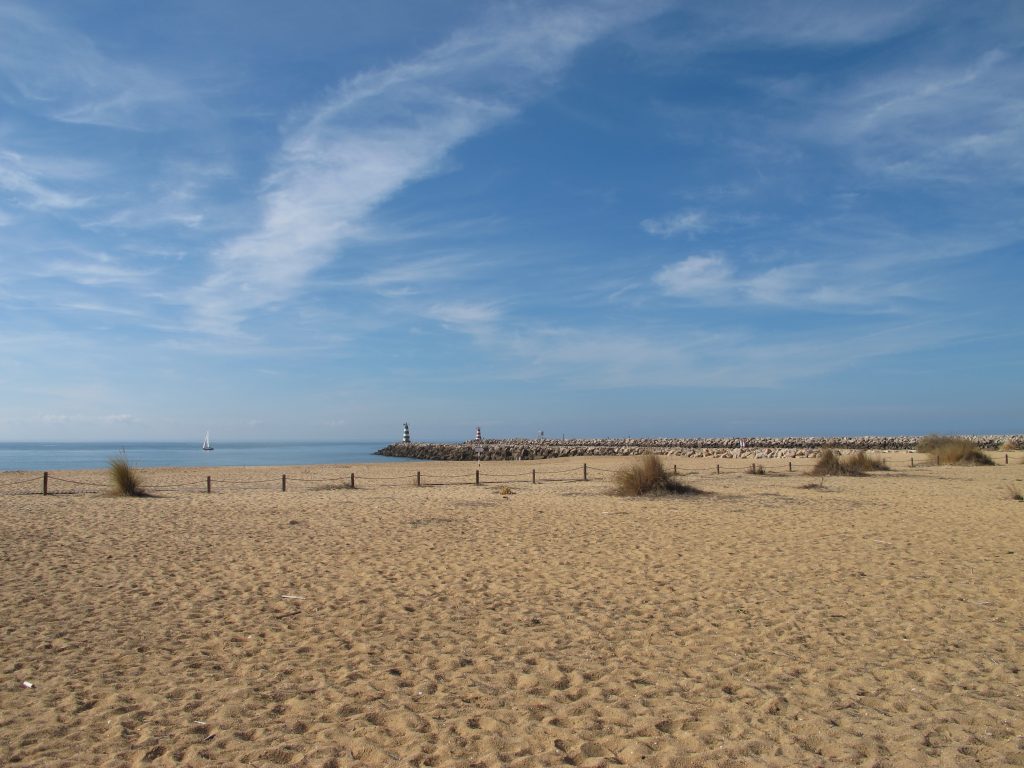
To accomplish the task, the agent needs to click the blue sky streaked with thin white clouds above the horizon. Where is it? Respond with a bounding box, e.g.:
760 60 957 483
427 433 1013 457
0 0 1024 440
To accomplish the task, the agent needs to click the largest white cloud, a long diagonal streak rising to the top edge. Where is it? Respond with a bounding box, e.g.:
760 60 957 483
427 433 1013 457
191 2 658 333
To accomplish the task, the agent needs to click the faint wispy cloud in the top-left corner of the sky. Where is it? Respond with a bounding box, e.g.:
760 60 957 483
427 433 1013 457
0 2 188 128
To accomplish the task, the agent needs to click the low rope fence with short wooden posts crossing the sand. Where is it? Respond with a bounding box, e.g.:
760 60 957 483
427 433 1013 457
0 454 1010 496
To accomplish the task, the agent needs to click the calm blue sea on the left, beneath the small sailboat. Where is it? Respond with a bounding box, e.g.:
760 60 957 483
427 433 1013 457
0 440 409 471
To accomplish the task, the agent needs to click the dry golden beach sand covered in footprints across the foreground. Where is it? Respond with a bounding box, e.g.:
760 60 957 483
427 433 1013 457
0 454 1024 766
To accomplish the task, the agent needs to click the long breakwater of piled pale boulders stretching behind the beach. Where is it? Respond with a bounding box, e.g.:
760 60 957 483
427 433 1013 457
377 435 1024 461
